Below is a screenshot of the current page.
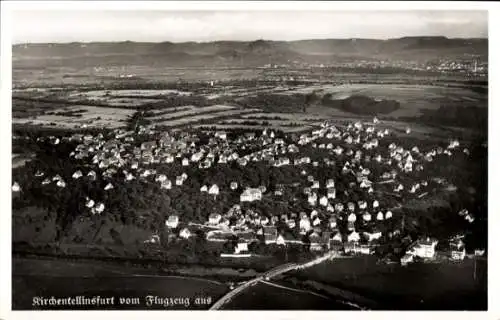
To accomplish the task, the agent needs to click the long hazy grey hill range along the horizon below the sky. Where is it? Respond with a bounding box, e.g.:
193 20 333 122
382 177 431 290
12 37 488 66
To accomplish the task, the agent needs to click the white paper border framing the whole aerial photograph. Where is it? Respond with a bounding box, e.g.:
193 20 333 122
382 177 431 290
0 1 500 320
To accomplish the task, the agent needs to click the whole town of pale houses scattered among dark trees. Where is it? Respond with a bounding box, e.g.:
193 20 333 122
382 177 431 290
12 117 485 265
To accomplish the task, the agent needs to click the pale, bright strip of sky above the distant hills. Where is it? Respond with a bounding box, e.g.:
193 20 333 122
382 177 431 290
12 10 488 43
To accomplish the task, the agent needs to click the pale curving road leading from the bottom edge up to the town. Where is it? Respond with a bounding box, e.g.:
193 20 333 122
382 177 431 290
209 252 337 310
